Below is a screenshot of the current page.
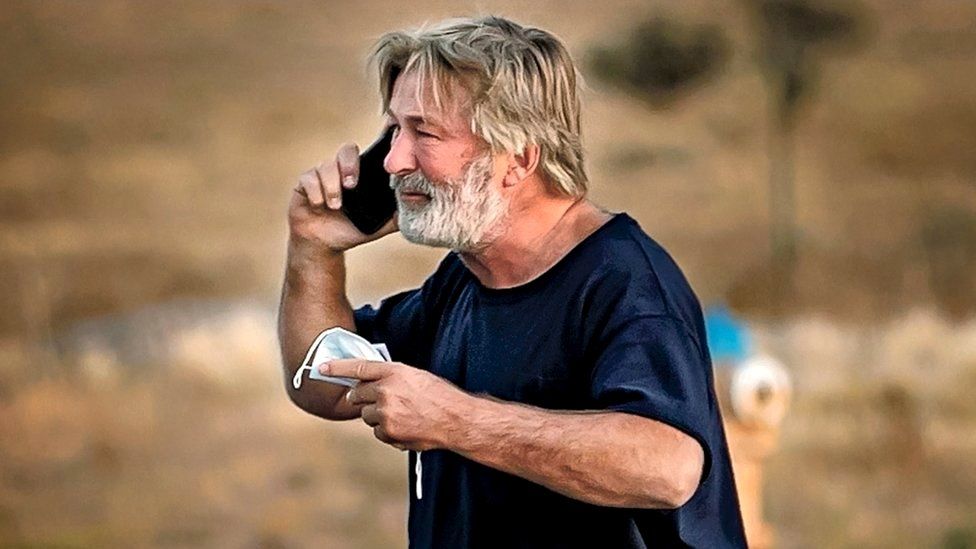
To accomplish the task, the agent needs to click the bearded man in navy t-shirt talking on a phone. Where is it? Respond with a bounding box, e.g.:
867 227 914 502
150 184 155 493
279 17 745 548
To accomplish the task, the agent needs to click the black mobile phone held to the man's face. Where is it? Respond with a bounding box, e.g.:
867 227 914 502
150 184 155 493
342 126 396 234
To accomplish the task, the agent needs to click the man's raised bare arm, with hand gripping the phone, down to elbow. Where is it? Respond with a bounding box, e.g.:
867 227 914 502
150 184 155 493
278 140 396 419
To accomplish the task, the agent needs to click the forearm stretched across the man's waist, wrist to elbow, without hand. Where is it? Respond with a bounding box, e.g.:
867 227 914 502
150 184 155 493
444 397 703 508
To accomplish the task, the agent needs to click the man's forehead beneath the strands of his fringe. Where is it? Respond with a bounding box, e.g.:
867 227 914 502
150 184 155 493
389 70 471 132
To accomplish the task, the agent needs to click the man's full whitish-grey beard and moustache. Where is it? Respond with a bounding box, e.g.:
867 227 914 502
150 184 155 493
390 154 508 252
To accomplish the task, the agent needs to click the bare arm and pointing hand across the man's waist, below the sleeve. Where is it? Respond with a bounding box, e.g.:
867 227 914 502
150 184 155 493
323 359 704 509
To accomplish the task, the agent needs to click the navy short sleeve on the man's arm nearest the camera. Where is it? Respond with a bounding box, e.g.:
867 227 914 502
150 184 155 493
591 315 714 480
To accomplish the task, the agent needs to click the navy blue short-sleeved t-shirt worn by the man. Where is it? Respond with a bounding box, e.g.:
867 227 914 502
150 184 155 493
355 214 745 549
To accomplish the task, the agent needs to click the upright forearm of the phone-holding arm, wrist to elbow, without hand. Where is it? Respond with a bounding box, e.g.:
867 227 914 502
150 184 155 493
278 241 358 419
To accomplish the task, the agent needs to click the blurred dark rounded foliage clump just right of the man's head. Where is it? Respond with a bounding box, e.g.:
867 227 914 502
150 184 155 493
586 17 730 108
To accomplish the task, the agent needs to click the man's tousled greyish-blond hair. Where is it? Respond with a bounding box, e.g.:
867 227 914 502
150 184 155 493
371 16 587 197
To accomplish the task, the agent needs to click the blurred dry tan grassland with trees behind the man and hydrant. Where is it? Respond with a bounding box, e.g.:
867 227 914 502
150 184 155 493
0 0 976 548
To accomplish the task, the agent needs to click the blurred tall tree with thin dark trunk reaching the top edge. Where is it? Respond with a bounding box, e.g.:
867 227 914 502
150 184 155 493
743 0 864 287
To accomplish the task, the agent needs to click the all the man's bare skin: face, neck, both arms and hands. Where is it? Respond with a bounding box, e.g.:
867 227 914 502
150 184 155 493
279 69 704 508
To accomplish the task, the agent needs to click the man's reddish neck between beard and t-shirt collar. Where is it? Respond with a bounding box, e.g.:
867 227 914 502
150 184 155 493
460 197 610 289
